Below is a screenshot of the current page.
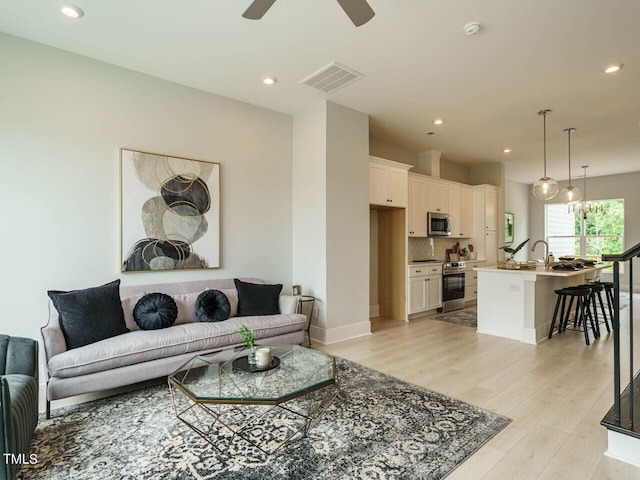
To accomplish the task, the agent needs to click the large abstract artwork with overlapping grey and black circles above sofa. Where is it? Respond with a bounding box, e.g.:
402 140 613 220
120 149 220 272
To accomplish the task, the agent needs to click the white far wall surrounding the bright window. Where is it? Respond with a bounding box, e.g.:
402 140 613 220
529 172 640 290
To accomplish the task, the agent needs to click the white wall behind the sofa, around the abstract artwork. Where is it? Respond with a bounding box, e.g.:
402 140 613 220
0 34 294 338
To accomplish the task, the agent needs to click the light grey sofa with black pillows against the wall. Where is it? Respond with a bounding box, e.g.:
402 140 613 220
41 278 307 418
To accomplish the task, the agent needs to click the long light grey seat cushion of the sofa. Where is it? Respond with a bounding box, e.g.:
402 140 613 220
47 313 307 378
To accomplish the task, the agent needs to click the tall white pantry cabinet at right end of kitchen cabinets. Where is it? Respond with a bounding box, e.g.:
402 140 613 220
471 185 498 265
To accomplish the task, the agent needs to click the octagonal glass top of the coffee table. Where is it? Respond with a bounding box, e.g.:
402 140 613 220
169 345 336 404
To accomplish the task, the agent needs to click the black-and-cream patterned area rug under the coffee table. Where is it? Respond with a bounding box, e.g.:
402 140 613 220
18 359 510 480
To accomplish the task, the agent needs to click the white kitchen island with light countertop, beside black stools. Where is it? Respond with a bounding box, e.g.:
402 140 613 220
474 264 605 345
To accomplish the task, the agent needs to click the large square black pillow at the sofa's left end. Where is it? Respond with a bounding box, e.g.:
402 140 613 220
47 280 128 350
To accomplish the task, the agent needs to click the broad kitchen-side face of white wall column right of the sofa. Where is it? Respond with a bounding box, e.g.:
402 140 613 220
326 102 371 342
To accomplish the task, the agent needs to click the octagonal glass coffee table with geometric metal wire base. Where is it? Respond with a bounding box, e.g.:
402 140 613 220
168 345 340 455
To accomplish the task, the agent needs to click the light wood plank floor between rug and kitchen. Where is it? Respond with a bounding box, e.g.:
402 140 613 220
314 301 640 480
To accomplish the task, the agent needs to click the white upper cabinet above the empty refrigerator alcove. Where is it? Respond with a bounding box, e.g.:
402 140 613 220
369 157 412 207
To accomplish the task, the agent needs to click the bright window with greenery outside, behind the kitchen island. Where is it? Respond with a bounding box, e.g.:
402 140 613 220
545 199 624 260
